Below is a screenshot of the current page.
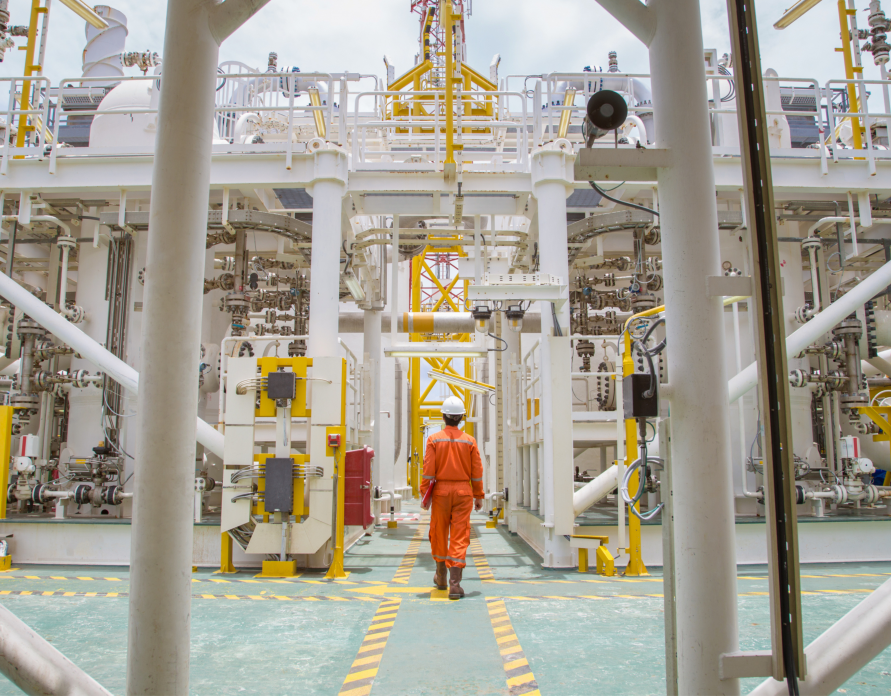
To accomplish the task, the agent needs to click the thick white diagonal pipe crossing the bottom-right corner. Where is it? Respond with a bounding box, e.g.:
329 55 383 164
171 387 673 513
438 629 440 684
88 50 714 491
750 580 891 696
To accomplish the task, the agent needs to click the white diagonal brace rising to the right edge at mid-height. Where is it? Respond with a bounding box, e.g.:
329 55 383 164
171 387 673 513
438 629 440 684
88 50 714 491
728 263 891 403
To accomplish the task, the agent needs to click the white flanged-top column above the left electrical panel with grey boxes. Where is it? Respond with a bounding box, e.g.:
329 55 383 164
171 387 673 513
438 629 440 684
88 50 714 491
306 145 347 358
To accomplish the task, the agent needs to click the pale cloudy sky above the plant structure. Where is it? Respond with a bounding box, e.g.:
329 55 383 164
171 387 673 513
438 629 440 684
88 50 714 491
0 0 891 91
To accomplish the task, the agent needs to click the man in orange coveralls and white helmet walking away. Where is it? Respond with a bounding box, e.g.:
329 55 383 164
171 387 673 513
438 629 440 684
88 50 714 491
421 396 485 599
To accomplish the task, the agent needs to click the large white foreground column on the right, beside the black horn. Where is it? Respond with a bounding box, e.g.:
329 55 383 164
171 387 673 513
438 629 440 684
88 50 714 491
646 0 739 696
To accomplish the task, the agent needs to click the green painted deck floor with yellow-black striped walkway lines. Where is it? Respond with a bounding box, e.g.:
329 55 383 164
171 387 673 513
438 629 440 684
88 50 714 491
0 502 891 696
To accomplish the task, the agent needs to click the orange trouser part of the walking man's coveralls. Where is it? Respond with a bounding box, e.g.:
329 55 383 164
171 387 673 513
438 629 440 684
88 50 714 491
430 481 473 568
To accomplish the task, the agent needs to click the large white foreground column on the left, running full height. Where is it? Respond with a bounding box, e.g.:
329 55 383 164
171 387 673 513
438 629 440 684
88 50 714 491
127 0 265 695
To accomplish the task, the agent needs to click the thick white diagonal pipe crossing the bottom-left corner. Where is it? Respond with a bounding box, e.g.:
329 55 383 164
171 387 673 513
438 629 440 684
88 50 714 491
0 606 111 696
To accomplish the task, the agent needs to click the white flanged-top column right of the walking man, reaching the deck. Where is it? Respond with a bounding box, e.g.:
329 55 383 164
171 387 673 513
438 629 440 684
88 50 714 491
532 143 575 567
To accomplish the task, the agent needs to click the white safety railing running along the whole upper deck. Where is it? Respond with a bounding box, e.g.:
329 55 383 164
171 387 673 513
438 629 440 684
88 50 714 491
0 69 891 175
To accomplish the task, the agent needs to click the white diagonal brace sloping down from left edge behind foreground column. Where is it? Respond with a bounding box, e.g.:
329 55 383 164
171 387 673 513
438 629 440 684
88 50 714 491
0 273 223 457
